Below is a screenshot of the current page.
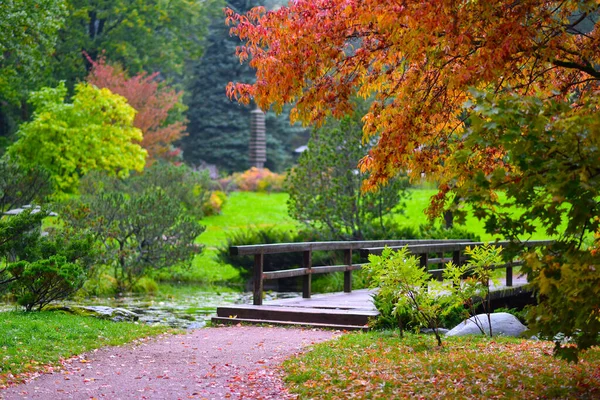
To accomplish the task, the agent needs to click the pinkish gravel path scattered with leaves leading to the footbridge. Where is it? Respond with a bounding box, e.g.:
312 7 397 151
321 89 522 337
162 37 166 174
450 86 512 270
0 326 336 400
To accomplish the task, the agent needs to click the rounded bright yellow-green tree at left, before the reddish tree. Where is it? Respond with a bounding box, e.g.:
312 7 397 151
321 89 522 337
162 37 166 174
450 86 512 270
8 82 146 193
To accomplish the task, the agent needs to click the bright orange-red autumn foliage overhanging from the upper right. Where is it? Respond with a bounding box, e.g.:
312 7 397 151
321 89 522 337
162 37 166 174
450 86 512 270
226 0 600 209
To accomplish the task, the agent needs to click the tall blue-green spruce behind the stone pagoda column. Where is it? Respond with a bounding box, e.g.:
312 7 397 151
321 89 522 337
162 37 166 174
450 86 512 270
182 0 307 172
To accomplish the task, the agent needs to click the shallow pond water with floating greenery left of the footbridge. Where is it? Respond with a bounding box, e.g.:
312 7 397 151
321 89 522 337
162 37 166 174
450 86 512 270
0 287 301 329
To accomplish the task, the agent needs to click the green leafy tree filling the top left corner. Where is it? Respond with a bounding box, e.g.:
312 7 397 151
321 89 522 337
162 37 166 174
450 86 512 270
0 0 66 141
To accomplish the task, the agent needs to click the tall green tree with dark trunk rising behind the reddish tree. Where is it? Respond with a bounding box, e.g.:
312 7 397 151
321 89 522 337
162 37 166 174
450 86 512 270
54 0 217 86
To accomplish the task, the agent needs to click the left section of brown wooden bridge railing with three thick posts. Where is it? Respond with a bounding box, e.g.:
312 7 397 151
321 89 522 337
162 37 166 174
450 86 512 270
229 239 468 305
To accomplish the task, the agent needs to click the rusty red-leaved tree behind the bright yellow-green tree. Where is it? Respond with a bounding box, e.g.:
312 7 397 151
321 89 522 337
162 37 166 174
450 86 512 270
87 57 186 165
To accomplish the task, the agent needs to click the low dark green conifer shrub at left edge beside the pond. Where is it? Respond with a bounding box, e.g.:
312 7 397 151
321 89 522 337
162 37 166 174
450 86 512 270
8 256 85 311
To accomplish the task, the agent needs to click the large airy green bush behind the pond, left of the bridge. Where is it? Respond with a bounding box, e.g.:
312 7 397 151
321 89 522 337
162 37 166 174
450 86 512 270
60 163 209 292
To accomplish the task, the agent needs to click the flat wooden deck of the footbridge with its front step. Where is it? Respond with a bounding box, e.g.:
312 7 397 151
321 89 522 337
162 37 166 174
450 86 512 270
212 276 528 330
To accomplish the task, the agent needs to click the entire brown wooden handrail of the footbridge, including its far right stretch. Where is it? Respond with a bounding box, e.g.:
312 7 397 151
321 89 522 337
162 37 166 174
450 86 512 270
229 239 552 305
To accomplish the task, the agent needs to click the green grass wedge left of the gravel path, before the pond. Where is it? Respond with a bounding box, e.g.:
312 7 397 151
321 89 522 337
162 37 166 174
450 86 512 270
0 311 170 388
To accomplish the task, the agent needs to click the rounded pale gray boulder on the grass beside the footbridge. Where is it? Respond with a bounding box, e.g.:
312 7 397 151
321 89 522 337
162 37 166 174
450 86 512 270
446 313 527 337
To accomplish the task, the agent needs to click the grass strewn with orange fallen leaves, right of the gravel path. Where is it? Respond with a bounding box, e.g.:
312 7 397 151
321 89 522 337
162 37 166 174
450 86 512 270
283 332 600 399
